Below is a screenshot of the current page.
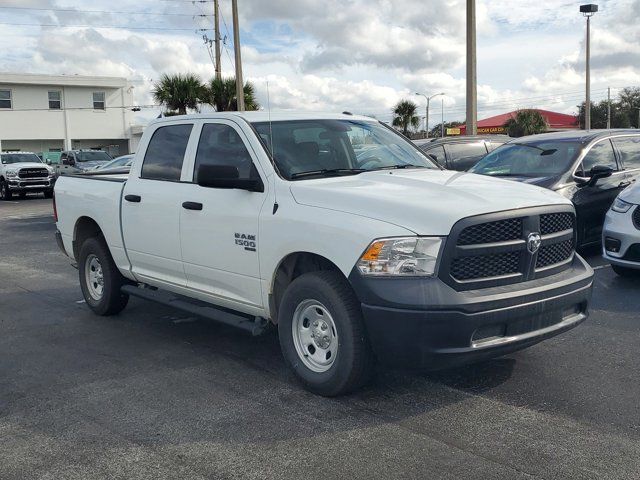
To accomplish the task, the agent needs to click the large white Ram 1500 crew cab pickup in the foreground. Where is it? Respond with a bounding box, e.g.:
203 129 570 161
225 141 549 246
54 112 593 395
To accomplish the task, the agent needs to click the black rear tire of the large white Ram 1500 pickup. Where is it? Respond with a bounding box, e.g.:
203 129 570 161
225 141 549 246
78 237 129 316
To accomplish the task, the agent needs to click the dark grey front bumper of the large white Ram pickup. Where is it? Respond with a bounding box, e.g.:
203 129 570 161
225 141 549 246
349 255 593 369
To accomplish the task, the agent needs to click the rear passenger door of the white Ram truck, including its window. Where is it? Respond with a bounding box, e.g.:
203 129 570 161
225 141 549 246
122 124 193 286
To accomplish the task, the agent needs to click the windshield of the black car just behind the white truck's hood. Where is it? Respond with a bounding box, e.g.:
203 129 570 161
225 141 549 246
469 141 582 177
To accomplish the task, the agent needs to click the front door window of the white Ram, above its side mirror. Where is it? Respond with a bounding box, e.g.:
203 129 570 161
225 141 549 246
193 123 257 183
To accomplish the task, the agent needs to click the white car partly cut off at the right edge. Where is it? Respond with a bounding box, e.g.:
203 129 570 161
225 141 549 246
602 184 640 277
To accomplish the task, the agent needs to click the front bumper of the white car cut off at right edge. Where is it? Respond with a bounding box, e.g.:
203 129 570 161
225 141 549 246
602 206 640 268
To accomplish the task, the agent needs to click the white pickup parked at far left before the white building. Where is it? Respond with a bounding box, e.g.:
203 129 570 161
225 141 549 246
0 152 56 200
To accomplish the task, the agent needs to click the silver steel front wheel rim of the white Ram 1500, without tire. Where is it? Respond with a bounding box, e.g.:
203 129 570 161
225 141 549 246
291 300 338 373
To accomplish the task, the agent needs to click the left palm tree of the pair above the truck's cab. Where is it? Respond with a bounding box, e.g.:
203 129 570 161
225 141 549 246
151 73 204 115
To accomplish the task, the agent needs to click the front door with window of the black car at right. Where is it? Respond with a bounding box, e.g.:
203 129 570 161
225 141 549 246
573 139 626 244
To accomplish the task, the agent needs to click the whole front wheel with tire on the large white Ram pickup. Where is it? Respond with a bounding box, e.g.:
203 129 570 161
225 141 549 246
278 271 374 396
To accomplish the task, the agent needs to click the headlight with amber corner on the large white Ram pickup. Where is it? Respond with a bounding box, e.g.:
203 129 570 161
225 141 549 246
358 237 443 276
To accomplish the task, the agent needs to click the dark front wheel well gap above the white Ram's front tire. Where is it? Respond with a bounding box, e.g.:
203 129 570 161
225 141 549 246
269 252 342 323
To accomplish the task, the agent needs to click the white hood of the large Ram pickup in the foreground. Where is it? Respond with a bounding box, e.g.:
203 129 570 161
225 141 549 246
291 170 571 235
